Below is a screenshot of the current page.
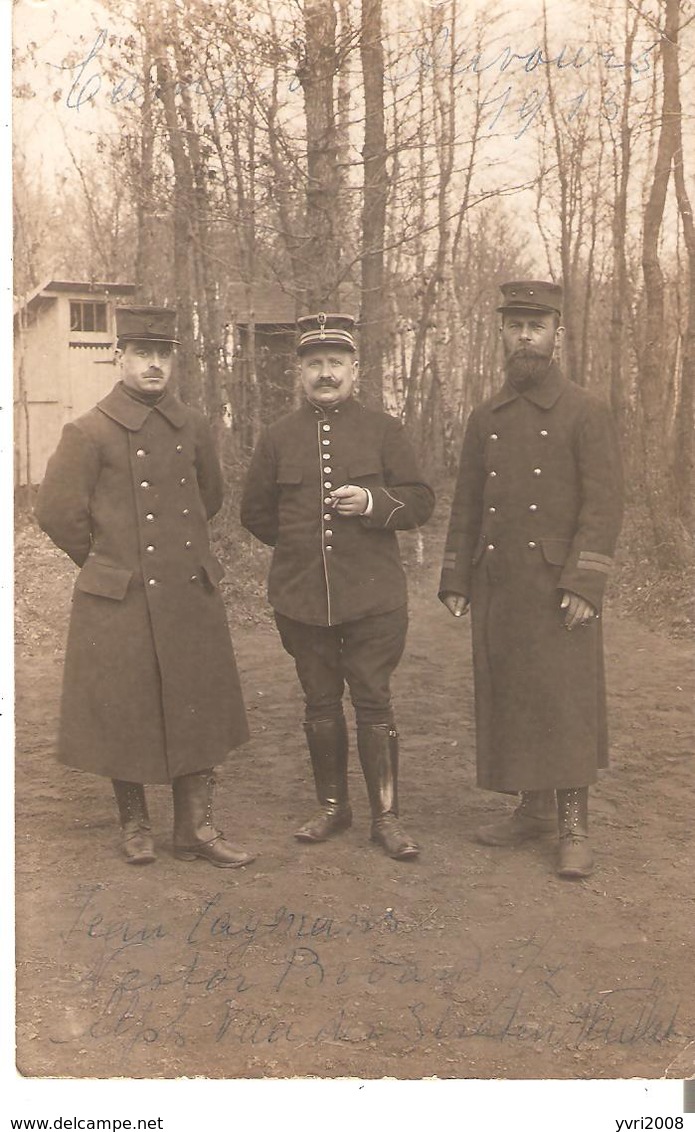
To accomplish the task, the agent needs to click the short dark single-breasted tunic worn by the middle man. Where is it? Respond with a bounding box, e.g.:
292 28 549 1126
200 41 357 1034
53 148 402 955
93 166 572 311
241 398 435 625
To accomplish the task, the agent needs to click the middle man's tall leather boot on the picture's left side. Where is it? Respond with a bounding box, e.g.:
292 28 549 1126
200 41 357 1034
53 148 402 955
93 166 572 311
294 715 352 841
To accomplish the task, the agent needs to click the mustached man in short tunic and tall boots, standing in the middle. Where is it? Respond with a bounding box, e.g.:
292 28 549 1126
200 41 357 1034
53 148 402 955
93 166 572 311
241 314 434 859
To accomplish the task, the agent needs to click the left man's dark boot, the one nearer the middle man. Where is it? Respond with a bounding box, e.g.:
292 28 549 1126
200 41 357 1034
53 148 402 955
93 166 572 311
172 770 255 868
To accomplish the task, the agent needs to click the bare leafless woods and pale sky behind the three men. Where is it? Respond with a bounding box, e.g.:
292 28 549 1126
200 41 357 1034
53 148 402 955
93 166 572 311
14 0 695 572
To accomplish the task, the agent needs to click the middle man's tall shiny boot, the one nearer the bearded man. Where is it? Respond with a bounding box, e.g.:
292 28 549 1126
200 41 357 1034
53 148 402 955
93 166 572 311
358 723 420 860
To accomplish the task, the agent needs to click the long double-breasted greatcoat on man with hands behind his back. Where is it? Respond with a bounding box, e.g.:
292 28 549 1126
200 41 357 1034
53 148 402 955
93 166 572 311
36 384 248 782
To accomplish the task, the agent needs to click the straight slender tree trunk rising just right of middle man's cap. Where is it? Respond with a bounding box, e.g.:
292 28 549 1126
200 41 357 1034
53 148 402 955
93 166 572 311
360 0 388 409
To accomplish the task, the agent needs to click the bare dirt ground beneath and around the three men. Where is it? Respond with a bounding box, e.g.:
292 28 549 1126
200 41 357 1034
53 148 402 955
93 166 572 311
16 518 695 1079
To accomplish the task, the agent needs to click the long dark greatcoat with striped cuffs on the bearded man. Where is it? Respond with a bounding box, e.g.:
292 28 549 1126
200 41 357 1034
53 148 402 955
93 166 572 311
439 366 623 792
